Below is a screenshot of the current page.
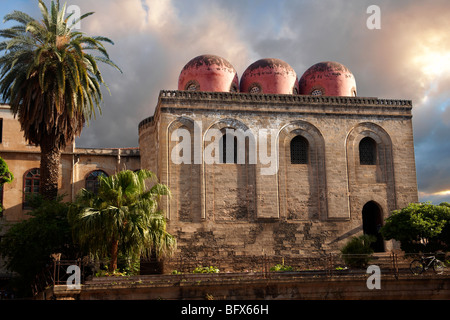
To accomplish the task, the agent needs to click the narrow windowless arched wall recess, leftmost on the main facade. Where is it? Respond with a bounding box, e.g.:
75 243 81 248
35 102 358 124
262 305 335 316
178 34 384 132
167 117 202 222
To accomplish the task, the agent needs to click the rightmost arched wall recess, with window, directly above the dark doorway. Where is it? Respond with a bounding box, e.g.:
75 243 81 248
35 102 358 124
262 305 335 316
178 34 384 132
346 122 396 214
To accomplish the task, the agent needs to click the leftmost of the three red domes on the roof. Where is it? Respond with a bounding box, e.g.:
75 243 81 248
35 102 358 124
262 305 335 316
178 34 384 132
178 55 239 92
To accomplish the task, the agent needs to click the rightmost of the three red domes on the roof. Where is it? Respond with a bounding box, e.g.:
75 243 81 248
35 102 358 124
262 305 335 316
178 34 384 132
299 61 356 97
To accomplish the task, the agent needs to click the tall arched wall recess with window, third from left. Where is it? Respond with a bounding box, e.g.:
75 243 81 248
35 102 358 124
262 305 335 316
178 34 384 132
278 120 328 220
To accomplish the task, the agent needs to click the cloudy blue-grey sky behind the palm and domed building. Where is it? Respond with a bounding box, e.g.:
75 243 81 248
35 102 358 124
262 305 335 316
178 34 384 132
0 0 450 204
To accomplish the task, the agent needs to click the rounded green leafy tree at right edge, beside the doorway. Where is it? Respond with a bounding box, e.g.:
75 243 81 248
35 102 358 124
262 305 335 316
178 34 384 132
380 202 450 253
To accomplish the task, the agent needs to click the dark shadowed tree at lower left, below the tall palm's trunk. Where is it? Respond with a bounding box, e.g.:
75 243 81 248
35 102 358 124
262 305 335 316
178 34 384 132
0 195 79 296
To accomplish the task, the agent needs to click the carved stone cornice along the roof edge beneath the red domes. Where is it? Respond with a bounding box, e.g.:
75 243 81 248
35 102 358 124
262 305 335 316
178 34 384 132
139 90 412 131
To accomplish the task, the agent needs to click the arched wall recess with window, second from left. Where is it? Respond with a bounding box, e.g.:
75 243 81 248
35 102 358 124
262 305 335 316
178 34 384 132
203 118 256 221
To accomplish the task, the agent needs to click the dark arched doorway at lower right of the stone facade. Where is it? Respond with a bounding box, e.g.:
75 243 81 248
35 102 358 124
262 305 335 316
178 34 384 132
362 201 384 252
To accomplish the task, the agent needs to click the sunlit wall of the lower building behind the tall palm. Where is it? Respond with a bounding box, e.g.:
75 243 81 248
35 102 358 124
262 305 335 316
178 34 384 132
0 105 140 224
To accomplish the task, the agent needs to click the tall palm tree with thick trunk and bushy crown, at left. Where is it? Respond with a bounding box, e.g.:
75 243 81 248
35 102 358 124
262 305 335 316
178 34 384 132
0 0 120 199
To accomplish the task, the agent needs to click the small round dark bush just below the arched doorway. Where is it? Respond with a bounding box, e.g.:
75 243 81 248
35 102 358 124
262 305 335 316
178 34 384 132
341 234 376 268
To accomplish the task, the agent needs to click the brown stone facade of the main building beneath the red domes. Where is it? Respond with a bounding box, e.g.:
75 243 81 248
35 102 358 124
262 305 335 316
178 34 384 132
139 91 418 268
